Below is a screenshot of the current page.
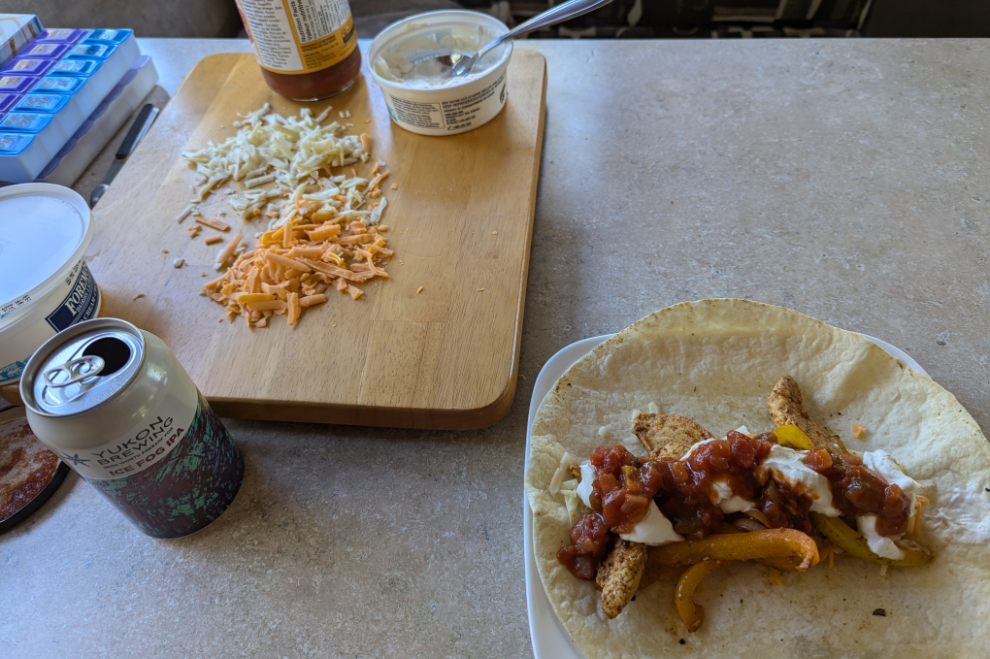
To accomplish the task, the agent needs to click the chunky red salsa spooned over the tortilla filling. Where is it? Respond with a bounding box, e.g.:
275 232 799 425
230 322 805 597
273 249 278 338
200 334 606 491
557 430 911 579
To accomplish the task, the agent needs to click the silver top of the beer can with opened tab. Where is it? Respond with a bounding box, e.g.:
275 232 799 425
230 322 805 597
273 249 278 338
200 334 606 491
21 318 145 417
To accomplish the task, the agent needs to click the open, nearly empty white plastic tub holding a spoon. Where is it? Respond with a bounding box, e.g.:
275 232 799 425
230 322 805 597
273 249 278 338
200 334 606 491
368 10 512 135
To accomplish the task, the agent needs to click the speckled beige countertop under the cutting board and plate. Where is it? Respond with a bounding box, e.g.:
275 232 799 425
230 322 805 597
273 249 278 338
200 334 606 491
0 40 990 659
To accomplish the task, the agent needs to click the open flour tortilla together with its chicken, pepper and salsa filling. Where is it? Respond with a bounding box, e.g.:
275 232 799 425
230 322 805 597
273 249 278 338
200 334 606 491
526 300 990 658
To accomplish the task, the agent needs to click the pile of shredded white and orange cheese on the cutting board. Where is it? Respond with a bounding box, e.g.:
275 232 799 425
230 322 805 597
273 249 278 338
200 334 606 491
179 104 392 327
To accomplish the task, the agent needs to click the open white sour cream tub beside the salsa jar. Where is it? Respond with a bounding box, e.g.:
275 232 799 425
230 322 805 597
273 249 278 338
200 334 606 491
368 10 512 135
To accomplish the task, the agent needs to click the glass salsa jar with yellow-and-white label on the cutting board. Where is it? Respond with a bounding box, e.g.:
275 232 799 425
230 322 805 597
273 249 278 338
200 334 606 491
237 0 361 101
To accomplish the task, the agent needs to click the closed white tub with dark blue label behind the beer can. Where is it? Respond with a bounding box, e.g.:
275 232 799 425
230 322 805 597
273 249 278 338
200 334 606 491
0 183 101 385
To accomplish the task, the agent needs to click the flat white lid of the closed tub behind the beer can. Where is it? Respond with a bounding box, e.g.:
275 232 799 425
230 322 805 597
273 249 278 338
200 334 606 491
0 183 93 327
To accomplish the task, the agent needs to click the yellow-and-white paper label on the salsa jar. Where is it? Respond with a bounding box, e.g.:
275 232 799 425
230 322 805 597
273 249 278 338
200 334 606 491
237 0 357 75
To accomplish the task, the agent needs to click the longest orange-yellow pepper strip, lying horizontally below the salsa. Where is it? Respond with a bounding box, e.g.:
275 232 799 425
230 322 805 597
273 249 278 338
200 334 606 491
649 529 818 572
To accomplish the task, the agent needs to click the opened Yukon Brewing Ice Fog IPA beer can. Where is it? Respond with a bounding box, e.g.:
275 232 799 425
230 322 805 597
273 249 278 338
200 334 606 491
20 318 244 538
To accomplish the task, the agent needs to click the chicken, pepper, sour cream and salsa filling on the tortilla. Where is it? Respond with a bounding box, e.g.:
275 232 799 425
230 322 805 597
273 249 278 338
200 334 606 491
557 375 931 631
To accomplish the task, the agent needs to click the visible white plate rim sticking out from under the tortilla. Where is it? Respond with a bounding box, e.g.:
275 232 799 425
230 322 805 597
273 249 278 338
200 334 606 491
523 334 928 659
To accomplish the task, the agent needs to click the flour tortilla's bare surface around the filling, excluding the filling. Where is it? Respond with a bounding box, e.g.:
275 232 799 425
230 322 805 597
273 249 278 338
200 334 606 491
526 300 990 659
